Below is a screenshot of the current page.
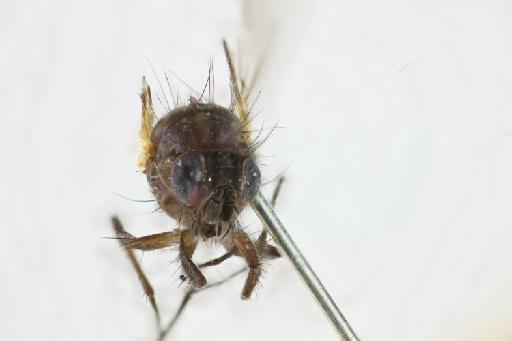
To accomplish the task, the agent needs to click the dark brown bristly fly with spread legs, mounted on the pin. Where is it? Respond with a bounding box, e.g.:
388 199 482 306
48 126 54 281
112 42 279 332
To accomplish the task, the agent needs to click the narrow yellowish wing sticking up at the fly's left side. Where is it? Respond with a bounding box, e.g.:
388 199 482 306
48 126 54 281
137 77 156 168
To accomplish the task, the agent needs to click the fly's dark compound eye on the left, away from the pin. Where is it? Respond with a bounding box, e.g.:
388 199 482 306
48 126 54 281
171 153 206 206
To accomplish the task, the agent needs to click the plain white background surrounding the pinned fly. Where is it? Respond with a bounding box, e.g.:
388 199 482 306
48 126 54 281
0 0 512 340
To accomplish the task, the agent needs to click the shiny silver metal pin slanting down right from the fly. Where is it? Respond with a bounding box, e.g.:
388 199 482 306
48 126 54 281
251 192 359 341
